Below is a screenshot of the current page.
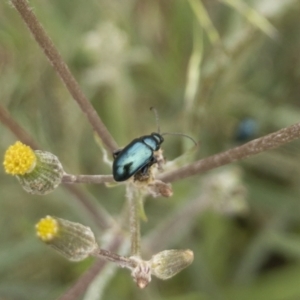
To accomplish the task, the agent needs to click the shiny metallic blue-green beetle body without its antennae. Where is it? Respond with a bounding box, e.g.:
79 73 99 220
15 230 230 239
113 132 164 181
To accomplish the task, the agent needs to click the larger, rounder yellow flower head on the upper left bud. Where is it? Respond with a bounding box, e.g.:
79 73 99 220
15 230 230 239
3 142 36 175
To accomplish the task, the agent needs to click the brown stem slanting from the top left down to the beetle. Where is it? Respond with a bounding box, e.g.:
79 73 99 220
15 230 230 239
11 0 118 152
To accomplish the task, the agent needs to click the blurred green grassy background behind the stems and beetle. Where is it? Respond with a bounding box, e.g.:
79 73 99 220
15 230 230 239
0 0 300 300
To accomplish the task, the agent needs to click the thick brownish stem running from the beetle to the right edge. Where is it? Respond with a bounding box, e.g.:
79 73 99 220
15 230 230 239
158 123 300 182
